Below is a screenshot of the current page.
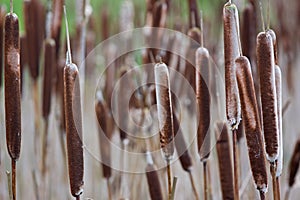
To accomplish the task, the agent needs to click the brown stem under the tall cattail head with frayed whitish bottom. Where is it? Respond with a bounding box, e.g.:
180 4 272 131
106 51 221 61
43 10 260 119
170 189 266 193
232 129 239 200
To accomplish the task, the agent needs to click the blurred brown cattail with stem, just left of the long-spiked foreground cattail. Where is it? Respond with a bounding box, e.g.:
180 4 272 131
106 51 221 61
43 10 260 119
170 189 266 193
42 38 55 175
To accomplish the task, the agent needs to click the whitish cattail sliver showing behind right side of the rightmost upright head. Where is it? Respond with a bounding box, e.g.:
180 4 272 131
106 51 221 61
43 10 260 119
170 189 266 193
275 65 283 177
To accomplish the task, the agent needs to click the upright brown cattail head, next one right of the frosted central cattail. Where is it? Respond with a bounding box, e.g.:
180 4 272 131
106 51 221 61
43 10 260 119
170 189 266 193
196 47 210 161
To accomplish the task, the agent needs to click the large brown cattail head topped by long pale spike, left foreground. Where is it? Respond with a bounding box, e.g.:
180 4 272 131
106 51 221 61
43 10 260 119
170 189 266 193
64 7 84 199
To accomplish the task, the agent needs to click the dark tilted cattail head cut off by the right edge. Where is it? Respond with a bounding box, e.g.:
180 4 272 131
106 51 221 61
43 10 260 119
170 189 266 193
289 140 300 187
